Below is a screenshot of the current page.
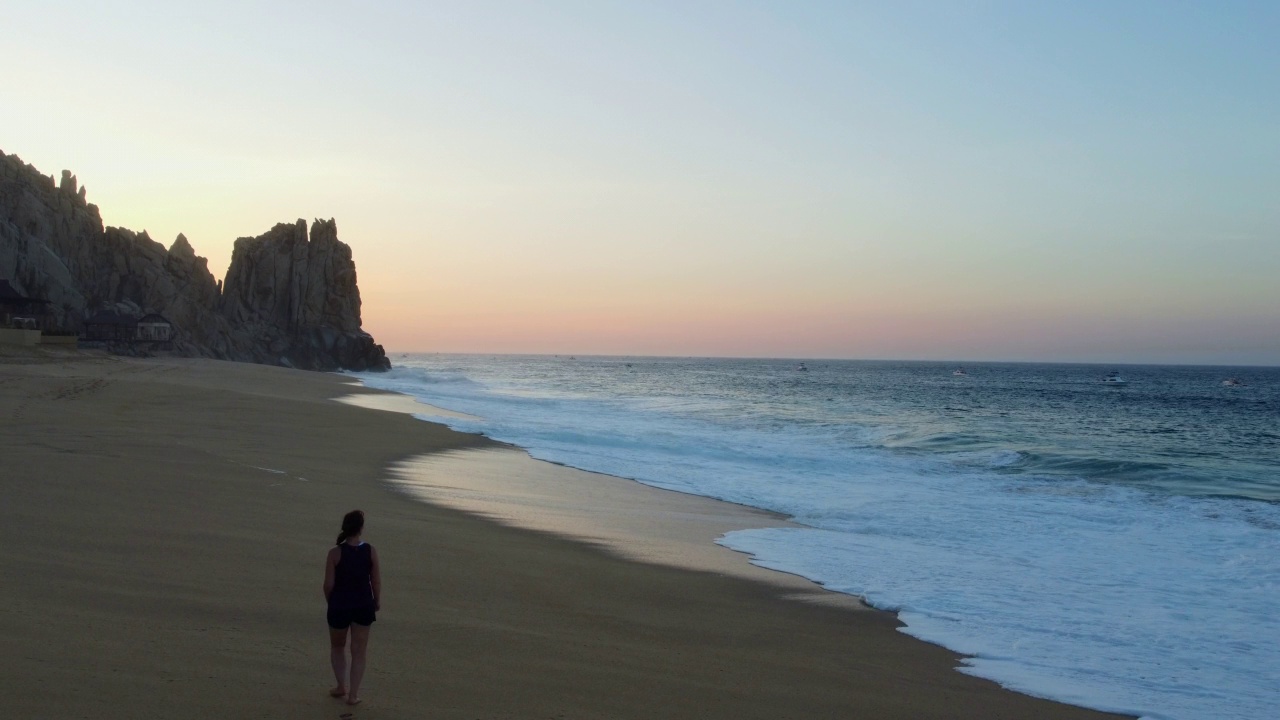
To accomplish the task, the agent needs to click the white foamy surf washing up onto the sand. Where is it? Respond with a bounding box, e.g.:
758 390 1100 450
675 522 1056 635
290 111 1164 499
362 368 1280 720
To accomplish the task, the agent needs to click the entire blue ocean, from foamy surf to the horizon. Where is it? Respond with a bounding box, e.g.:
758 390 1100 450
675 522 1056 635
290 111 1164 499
360 355 1280 720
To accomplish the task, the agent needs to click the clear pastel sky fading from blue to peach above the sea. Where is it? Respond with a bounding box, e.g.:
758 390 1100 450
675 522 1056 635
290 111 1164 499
0 0 1280 364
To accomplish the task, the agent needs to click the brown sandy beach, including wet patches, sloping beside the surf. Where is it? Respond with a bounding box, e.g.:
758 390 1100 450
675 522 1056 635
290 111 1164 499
0 348 1131 720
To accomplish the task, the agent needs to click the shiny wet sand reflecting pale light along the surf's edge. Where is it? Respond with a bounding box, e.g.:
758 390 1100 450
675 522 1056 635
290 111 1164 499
335 383 870 604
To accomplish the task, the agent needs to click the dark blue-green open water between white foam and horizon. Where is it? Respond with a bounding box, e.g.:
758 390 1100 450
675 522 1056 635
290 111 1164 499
415 355 1280 501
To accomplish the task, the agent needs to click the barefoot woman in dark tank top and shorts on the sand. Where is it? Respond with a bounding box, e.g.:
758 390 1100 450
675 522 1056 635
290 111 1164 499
324 510 381 705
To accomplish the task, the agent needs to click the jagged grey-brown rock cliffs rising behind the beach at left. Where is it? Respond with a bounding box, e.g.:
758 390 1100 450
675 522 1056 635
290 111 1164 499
0 147 390 370
